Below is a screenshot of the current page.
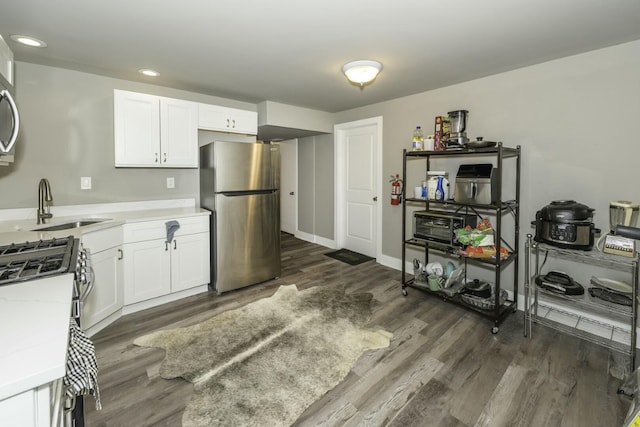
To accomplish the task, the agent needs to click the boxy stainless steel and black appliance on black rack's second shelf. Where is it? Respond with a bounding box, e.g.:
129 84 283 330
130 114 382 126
454 163 498 205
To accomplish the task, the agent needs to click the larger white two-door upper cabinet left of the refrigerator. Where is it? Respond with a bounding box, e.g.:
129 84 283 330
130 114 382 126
114 90 198 168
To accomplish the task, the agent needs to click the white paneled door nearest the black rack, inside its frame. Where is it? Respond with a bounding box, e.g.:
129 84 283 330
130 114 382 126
336 119 382 258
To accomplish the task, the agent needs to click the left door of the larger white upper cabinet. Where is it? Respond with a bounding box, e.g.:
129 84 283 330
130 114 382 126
113 90 160 166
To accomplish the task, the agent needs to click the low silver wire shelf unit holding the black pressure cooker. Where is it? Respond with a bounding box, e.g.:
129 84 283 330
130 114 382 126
524 234 639 372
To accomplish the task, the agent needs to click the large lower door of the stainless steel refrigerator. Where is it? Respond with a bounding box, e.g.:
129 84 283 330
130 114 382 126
211 191 280 293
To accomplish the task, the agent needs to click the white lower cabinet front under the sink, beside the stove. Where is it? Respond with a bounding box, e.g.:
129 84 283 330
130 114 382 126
81 227 124 329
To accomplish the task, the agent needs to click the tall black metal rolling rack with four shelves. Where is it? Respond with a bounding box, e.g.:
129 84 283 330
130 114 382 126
402 142 521 334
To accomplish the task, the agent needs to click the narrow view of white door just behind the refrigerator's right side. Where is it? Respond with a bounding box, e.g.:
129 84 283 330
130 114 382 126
278 139 298 235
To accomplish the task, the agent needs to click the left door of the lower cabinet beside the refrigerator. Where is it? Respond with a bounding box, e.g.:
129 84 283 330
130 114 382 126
123 240 171 305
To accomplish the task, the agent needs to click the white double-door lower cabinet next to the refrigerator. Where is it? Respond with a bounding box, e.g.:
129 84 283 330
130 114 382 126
124 216 210 306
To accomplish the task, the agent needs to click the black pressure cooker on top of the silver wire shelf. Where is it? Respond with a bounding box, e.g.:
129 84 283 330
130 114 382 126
534 200 600 251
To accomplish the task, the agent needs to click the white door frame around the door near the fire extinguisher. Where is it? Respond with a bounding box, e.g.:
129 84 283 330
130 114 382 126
333 116 384 260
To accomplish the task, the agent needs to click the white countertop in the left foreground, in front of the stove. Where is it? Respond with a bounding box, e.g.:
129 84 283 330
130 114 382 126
0 274 73 400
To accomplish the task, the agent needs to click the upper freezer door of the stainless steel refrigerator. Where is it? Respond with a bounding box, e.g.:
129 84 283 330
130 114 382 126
204 141 280 193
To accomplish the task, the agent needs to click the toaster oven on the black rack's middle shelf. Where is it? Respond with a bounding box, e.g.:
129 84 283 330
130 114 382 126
413 210 478 245
